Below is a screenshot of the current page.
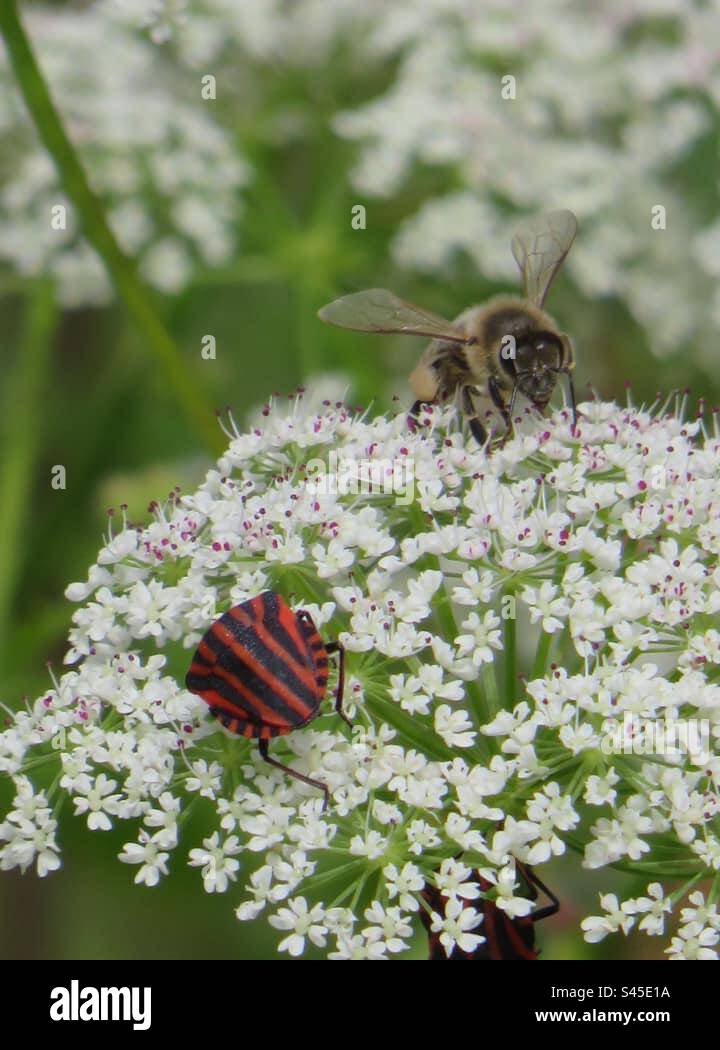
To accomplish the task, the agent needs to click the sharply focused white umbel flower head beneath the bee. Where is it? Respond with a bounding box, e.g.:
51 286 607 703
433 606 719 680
0 395 720 959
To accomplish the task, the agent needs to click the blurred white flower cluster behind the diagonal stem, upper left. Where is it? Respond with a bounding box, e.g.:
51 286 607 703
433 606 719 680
0 5 249 306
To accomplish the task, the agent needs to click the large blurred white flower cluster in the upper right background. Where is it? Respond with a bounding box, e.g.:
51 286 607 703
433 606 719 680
336 0 720 368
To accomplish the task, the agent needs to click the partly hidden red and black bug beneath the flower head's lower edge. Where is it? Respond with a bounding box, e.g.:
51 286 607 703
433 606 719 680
420 861 560 962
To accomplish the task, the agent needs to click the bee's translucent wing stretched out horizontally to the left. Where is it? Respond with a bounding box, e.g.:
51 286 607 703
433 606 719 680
318 288 470 343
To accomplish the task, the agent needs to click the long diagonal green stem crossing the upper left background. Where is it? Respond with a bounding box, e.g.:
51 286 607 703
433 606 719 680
0 0 224 452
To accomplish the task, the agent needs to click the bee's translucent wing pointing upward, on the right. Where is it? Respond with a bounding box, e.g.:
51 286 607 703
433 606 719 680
512 210 577 307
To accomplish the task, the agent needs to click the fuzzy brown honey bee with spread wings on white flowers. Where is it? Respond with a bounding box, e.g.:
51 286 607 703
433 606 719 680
318 210 577 444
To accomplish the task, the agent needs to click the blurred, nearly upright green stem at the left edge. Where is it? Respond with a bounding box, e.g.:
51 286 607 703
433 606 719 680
0 280 57 665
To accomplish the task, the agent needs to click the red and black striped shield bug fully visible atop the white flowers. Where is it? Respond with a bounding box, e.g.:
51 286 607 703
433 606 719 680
185 591 352 810
